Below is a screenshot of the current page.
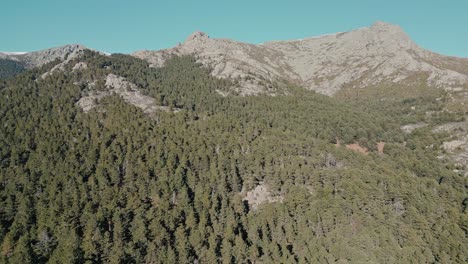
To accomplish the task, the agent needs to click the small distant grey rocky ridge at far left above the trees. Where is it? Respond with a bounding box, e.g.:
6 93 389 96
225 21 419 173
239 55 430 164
0 44 87 68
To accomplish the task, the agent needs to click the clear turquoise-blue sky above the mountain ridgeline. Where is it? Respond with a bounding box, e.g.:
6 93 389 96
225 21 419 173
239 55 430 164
0 0 468 57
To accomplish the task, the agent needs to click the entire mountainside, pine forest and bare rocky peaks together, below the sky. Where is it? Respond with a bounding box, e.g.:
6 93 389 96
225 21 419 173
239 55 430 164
0 23 468 264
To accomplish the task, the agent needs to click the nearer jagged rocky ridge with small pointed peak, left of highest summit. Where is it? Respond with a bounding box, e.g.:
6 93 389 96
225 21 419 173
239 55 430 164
133 32 288 95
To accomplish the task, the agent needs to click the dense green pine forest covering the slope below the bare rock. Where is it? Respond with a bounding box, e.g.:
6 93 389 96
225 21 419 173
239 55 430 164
0 51 468 263
